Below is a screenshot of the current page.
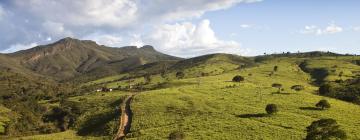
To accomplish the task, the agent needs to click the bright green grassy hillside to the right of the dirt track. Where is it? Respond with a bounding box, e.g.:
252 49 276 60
127 56 360 139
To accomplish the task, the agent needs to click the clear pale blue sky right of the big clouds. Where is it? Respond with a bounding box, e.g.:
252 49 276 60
204 0 360 54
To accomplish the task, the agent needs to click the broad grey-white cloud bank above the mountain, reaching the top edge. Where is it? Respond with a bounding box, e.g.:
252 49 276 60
0 0 261 54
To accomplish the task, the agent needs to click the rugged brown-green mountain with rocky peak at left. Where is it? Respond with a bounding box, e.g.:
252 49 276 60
0 38 180 80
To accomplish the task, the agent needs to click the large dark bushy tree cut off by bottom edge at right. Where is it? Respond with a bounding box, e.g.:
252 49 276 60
305 119 346 140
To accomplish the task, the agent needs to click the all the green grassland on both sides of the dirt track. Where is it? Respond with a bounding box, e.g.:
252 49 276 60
9 57 360 140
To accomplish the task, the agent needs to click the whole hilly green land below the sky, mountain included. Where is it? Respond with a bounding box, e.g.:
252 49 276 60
0 38 360 140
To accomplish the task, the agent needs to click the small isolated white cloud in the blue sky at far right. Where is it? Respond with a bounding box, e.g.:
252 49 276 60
300 23 344 35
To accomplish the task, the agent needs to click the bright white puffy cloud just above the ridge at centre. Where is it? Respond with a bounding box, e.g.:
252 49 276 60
143 20 247 57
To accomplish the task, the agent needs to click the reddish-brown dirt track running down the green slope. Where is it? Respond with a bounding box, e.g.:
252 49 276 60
114 95 134 140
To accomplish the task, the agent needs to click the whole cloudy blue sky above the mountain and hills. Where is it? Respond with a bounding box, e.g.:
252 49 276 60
0 0 360 57
